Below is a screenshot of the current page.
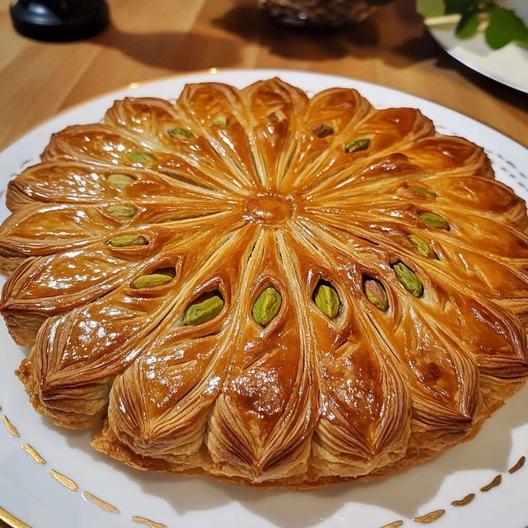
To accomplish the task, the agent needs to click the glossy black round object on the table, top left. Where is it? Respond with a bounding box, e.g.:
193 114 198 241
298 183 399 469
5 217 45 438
10 0 109 41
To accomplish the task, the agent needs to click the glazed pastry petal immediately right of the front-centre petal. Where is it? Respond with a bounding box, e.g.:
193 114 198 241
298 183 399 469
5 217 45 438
286 231 411 477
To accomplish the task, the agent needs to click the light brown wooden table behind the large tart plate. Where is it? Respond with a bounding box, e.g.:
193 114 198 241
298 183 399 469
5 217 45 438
0 0 528 528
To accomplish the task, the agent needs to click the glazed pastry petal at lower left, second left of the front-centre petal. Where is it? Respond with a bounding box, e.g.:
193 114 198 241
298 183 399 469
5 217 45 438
20 252 185 429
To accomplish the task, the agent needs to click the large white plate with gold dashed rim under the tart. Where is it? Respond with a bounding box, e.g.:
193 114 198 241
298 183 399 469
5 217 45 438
0 70 528 528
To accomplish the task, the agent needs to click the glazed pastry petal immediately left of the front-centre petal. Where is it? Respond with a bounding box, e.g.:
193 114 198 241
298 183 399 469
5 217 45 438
103 228 262 464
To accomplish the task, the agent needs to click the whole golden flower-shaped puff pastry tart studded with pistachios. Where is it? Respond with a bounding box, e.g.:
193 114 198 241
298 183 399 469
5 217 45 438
0 79 528 488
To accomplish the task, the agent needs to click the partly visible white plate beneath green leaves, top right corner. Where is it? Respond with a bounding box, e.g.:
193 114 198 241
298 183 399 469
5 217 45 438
430 0 528 93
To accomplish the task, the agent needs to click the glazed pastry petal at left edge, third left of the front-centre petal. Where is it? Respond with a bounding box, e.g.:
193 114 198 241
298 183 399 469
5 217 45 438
1 214 241 343
